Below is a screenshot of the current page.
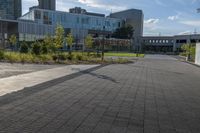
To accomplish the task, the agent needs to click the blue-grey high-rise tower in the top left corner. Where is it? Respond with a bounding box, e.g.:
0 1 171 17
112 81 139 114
0 0 22 19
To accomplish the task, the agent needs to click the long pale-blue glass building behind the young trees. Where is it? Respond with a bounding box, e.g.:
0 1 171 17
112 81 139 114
18 9 123 43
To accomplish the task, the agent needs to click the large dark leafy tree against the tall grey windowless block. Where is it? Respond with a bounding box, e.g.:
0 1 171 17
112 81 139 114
112 25 134 39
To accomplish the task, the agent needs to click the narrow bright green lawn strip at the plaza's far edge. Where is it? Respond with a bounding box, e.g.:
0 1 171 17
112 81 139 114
105 52 144 58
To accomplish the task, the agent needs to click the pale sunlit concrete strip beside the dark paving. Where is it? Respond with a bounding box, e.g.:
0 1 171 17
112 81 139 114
0 65 98 96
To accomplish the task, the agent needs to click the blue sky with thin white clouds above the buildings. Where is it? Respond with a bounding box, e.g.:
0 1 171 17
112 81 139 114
22 0 200 35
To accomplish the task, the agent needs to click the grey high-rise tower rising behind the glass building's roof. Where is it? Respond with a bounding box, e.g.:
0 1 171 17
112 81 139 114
38 0 56 10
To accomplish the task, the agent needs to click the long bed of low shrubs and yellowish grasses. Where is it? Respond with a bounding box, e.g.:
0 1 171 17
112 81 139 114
0 51 138 64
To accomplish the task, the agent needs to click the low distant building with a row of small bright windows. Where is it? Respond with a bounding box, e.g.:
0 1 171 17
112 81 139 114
142 34 200 53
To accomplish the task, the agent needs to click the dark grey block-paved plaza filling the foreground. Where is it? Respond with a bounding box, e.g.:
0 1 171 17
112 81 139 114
0 55 200 133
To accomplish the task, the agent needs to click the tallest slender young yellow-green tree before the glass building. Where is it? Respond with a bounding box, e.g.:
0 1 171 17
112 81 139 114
55 25 65 49
